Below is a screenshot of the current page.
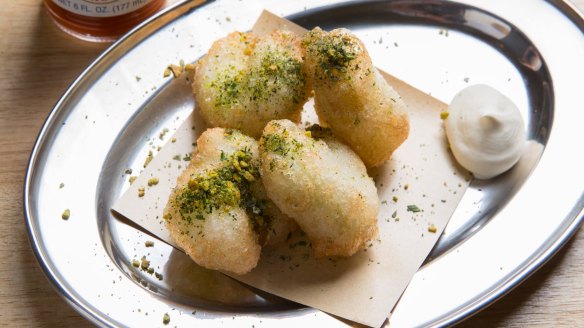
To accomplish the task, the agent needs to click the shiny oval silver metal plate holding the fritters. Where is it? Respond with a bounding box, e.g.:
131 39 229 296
24 0 584 327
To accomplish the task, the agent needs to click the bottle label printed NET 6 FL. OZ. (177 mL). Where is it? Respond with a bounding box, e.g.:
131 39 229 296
52 0 152 17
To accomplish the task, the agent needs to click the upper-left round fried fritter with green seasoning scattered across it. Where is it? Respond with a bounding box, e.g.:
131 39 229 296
193 31 308 138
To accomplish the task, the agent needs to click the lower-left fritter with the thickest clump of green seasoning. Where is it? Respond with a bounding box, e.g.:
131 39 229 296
164 128 293 274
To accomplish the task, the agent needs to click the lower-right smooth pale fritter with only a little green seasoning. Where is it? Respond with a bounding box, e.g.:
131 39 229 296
260 120 379 257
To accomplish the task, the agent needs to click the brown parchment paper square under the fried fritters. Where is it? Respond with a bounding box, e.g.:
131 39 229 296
112 12 470 327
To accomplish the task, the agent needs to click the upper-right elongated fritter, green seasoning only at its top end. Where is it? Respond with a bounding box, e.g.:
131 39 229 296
303 27 409 167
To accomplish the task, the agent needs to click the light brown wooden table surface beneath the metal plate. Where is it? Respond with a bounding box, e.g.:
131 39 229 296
0 0 584 327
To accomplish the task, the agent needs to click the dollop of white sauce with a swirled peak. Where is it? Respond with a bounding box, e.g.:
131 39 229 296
444 84 525 179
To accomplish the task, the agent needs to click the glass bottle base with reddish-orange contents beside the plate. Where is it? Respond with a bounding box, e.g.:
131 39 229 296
44 0 165 42
